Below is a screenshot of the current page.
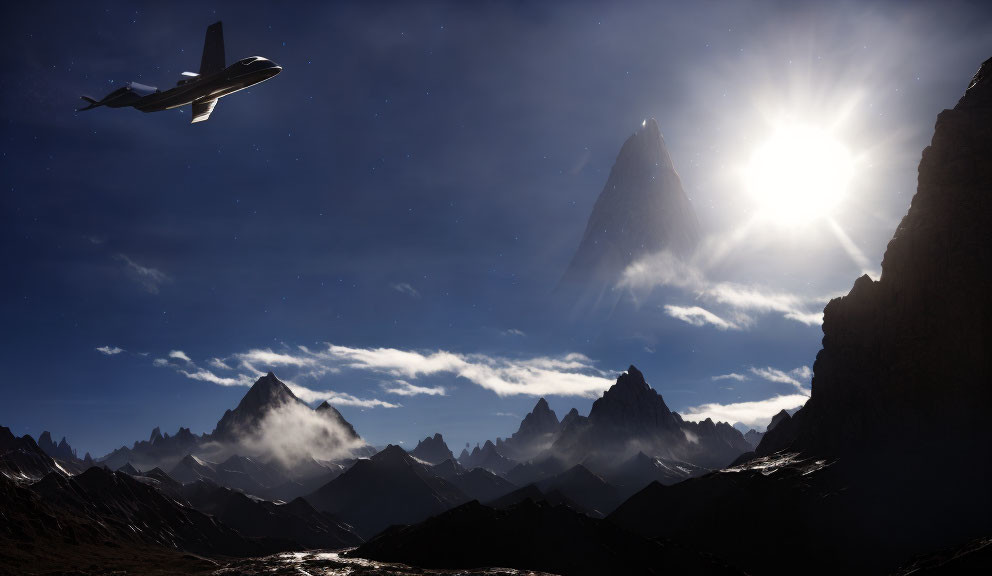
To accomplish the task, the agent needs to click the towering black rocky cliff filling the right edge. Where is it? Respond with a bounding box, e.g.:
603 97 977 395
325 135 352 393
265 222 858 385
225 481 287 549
611 59 992 574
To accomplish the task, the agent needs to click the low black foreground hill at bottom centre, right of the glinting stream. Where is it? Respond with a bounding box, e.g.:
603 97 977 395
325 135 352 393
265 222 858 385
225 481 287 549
349 500 736 575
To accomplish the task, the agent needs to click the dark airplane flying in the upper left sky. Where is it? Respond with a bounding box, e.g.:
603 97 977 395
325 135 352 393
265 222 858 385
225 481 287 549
76 22 282 124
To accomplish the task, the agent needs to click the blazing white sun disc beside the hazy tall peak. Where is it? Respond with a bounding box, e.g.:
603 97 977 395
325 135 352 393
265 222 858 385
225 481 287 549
746 124 854 226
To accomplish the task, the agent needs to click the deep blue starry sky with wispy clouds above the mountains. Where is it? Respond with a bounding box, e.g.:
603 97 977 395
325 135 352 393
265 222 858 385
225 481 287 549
0 1 992 455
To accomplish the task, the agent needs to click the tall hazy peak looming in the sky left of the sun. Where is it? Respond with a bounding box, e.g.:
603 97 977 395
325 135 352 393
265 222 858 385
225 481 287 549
559 118 700 307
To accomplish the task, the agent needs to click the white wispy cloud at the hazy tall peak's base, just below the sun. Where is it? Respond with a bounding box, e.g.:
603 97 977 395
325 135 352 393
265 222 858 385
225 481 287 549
618 251 829 330
